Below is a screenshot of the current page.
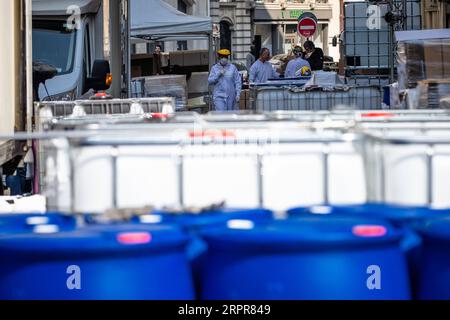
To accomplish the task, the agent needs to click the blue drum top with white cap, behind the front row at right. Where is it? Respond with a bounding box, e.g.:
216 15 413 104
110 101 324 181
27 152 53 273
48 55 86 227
288 203 450 222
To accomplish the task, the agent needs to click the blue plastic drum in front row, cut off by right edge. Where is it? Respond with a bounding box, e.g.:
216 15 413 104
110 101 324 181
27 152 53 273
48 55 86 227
417 215 450 300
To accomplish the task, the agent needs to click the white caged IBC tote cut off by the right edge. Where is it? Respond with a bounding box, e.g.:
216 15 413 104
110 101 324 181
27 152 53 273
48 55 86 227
363 123 450 208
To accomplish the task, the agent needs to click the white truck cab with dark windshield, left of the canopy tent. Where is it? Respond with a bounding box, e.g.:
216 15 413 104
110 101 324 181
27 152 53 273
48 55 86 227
33 0 110 101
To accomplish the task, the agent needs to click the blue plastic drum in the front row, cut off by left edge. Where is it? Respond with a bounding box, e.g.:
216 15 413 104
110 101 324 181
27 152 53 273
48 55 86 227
0 225 194 300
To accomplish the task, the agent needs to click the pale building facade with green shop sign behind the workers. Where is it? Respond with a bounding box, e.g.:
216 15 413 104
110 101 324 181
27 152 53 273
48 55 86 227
134 0 341 63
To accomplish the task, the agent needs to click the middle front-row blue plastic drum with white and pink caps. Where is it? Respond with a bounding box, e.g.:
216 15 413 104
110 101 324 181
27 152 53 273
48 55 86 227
201 217 410 300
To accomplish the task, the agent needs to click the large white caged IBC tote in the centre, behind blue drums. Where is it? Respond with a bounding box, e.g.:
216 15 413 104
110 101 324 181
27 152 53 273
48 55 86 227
40 123 366 212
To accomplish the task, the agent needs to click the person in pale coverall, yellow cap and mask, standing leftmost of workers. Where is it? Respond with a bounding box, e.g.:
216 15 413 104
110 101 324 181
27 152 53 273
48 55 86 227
208 49 242 111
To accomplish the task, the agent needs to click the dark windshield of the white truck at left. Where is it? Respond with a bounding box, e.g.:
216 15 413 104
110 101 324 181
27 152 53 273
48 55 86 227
33 20 76 75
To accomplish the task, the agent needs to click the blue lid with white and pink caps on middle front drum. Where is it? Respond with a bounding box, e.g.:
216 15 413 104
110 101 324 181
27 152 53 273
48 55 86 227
201 217 402 249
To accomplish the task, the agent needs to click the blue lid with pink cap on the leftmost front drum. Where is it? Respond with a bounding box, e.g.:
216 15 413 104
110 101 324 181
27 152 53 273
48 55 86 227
0 224 188 254
